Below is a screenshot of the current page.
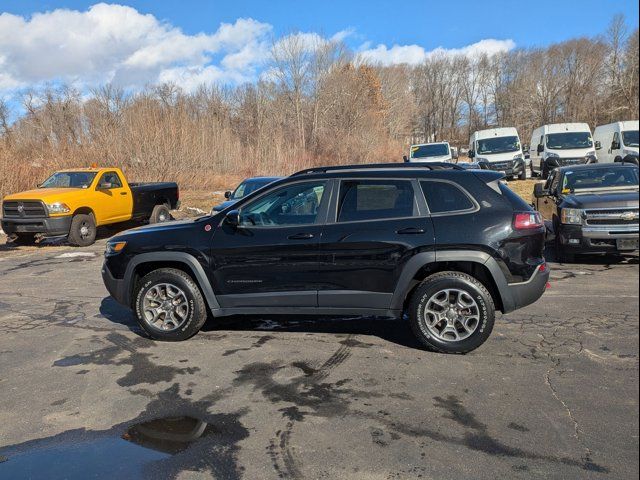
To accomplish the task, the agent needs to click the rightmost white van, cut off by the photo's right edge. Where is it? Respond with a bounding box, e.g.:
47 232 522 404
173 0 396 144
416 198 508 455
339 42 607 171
593 120 638 165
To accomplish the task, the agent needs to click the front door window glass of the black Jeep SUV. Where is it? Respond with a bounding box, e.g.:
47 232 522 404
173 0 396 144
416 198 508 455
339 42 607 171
240 182 325 227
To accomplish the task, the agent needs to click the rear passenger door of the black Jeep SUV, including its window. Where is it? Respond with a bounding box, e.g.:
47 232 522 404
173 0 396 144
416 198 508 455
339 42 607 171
318 178 434 309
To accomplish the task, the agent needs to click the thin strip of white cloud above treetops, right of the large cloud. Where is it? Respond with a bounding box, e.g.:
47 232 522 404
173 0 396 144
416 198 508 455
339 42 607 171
359 38 516 65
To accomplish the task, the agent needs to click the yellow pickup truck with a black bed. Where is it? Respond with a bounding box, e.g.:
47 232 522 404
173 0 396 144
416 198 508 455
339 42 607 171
2 168 179 246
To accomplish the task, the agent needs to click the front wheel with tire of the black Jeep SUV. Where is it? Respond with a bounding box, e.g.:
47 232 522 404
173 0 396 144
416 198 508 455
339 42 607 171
134 268 208 342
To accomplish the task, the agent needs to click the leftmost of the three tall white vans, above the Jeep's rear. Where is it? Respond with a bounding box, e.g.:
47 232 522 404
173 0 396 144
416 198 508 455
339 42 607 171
469 127 527 180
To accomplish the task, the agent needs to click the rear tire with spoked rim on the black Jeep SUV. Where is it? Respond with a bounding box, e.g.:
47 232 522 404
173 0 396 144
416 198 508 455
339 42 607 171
409 271 495 353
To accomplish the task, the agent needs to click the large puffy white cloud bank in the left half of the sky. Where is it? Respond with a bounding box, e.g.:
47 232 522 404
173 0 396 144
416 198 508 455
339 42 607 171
0 3 272 91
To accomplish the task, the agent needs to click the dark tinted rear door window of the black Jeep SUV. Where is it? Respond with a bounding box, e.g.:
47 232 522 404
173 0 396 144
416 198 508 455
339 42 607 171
338 180 418 222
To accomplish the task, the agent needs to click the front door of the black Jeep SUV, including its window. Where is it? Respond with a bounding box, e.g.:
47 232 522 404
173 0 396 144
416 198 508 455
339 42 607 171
211 180 330 308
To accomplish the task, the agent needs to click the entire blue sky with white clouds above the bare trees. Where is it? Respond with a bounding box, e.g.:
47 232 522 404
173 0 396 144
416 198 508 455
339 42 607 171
0 0 638 100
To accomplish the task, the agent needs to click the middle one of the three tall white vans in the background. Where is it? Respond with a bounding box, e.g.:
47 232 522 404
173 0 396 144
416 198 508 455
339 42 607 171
530 123 599 179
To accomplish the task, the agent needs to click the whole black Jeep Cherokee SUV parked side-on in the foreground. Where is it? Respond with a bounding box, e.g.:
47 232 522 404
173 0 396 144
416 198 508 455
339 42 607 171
102 163 549 353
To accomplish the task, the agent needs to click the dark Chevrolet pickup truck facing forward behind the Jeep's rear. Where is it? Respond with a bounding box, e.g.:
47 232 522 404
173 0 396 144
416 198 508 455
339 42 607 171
533 163 638 262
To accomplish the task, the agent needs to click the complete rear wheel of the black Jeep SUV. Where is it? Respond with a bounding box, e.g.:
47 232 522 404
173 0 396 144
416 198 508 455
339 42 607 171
409 272 495 353
